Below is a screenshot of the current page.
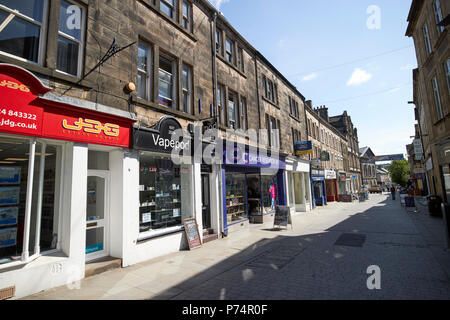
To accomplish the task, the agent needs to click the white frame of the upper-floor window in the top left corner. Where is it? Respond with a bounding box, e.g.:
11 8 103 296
0 0 48 66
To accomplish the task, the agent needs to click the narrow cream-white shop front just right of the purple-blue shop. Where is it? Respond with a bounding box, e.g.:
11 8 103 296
285 158 312 215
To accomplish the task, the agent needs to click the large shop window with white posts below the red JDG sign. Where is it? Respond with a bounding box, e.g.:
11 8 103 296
0 136 61 264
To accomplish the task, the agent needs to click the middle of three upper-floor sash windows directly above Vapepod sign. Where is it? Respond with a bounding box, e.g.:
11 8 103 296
159 54 177 108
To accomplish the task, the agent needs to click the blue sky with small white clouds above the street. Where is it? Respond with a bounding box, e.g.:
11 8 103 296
211 0 417 155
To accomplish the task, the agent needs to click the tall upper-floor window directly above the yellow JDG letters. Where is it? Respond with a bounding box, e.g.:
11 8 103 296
56 0 85 76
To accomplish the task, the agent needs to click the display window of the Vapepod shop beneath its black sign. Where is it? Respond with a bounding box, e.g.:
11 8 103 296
139 152 193 232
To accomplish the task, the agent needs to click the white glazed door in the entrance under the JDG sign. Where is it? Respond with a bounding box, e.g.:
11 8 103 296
86 170 110 262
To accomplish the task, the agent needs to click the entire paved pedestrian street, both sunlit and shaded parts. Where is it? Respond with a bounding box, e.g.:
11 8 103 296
26 194 450 300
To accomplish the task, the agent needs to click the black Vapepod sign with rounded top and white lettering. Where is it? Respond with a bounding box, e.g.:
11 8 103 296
133 116 192 155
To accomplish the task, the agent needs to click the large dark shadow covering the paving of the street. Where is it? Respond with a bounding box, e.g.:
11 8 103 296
149 196 450 300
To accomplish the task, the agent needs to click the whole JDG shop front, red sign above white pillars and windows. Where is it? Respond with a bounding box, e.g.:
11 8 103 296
0 64 135 297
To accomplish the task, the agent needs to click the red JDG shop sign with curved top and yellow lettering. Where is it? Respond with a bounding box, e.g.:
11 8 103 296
0 64 133 148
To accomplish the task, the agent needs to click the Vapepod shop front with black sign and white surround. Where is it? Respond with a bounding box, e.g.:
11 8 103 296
123 116 206 266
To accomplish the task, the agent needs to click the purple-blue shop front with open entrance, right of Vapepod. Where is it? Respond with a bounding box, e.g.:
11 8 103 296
222 145 286 234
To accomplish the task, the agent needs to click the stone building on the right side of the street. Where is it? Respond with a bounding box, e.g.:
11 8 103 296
406 0 450 202
